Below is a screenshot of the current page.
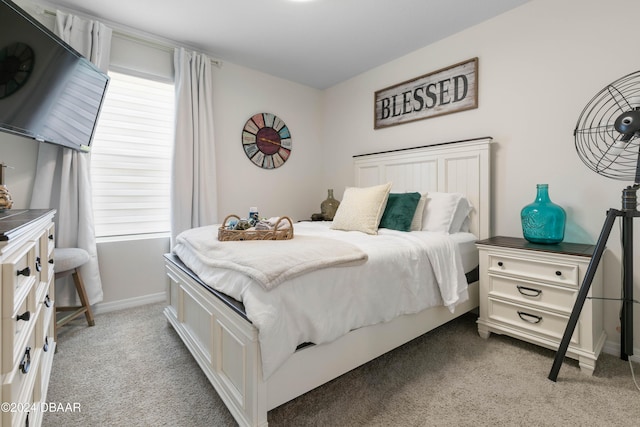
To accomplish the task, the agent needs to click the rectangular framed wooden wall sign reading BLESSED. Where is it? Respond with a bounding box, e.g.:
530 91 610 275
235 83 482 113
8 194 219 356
374 58 478 129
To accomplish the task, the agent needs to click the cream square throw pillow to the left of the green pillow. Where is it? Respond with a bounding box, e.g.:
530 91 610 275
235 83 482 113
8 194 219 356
331 182 391 234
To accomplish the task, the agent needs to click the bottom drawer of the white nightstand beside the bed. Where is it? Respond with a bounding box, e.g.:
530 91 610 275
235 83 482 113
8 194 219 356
488 298 580 346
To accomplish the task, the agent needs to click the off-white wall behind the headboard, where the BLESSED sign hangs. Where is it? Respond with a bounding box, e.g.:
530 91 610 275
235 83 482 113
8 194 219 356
322 0 640 353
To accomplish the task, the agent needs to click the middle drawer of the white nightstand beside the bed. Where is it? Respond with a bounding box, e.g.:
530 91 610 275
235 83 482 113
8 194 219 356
488 275 578 315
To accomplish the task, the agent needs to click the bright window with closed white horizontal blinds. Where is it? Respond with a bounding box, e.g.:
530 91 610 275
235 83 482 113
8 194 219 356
91 71 175 237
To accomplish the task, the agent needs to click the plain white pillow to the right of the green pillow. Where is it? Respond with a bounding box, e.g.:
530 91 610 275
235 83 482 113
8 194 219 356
422 192 472 233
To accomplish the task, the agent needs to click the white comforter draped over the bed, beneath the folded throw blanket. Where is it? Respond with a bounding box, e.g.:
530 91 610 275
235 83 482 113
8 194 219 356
174 222 468 380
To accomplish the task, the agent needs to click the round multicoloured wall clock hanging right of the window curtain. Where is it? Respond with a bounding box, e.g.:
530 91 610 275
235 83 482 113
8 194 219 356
242 113 292 169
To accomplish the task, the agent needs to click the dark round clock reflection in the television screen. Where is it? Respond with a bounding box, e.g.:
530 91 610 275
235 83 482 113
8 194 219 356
0 43 34 99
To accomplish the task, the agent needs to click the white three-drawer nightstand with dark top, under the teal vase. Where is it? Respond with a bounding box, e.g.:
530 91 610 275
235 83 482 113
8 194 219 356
476 236 606 375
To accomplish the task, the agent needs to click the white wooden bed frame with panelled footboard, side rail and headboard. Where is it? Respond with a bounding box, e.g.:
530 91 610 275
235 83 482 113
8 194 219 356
164 137 491 426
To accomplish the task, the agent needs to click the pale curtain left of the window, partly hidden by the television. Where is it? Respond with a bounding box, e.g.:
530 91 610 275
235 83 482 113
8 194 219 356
31 11 111 305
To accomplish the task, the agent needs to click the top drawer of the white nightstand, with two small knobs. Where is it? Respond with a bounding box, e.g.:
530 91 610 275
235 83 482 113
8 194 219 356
488 254 580 287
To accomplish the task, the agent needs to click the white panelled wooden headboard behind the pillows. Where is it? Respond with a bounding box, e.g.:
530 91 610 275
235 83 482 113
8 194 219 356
354 137 492 239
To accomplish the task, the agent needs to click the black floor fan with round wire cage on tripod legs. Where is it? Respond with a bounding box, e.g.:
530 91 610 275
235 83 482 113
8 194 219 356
549 71 640 381
